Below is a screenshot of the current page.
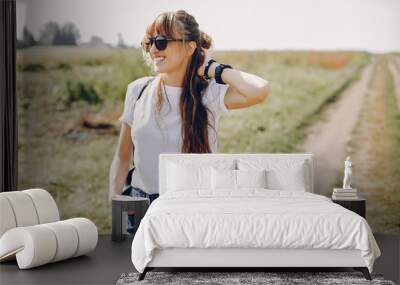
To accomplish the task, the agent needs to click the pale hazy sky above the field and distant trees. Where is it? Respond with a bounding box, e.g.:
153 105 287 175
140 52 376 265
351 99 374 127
17 0 400 52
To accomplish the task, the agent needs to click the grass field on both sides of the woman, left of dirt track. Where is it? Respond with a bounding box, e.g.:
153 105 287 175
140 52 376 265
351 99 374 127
17 47 394 233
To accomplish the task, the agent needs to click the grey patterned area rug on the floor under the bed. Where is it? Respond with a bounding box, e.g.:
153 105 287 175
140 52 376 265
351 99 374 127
117 271 395 285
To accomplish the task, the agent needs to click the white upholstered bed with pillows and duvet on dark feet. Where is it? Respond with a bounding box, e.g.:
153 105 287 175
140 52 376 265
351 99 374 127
131 153 381 280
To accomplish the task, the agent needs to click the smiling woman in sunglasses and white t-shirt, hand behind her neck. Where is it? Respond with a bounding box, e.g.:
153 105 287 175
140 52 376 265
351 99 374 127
109 10 270 233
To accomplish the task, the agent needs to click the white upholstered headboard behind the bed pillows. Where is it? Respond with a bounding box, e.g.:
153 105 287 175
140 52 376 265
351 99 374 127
158 153 314 195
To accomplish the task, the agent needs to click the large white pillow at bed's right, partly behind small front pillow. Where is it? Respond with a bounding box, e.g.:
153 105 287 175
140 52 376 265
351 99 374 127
238 159 307 191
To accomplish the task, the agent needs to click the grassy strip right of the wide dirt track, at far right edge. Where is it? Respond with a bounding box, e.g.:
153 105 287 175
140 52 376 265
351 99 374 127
349 58 400 234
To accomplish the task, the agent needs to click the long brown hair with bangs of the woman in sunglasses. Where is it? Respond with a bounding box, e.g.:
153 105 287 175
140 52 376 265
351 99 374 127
143 10 215 153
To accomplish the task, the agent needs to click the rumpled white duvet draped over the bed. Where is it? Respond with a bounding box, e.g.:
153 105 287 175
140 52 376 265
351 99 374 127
132 189 380 272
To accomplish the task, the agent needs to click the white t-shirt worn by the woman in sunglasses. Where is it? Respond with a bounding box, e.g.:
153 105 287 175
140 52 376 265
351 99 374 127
119 75 229 194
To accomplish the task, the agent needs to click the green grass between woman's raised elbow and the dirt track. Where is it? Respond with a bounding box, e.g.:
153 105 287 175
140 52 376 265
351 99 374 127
219 51 369 153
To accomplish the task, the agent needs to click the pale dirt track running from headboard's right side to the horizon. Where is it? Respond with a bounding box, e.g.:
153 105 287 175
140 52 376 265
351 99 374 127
297 58 375 196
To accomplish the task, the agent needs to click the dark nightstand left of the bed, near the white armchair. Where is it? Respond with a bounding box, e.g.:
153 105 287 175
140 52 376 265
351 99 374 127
111 195 150 241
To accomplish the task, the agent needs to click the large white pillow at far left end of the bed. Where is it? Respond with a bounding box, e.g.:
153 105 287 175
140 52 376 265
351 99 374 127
167 162 211 191
